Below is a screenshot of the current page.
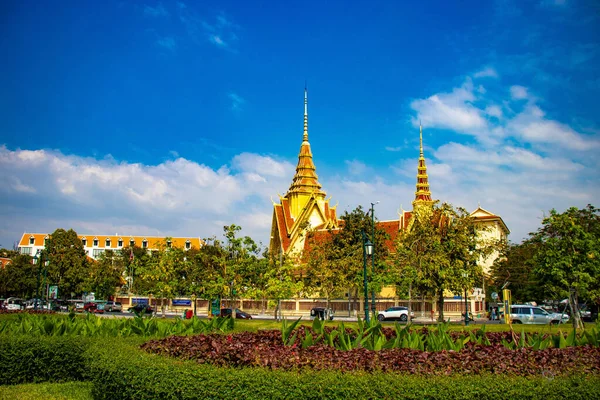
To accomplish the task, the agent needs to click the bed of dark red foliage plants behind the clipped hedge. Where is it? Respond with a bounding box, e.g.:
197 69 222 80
142 327 600 376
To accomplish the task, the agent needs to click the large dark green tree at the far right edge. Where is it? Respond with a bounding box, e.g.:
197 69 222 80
530 204 600 327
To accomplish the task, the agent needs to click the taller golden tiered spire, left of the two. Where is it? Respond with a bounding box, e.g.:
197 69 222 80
288 86 325 197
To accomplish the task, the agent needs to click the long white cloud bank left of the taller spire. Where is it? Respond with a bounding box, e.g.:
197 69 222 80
0 146 294 246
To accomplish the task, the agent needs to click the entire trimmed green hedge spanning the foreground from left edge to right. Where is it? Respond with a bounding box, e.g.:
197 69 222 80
0 336 600 400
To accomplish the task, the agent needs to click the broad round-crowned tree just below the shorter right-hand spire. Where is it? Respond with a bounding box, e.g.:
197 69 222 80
395 203 498 321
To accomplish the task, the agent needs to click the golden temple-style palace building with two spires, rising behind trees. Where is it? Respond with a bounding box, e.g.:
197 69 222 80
269 89 510 274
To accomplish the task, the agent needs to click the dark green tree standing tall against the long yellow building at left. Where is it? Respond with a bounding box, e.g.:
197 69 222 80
44 229 90 298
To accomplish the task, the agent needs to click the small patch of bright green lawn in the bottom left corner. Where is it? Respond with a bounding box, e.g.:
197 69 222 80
0 382 92 400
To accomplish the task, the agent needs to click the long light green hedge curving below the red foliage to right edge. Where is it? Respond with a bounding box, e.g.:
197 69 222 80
89 343 600 400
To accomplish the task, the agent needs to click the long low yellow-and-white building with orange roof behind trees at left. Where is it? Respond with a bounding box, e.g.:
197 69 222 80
18 232 203 260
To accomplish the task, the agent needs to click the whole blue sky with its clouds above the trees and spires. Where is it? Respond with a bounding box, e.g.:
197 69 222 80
0 0 600 247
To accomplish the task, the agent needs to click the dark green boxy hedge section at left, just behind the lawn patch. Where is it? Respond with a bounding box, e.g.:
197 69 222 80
0 335 90 385
